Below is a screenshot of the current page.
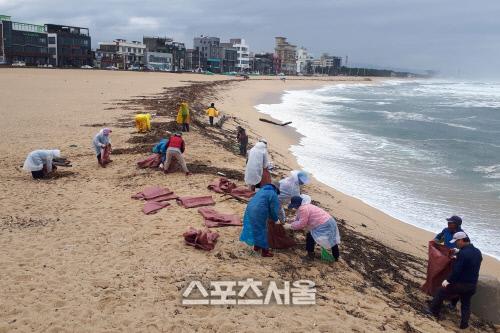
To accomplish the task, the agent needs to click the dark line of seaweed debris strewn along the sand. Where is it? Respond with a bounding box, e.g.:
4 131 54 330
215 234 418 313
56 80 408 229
114 80 494 332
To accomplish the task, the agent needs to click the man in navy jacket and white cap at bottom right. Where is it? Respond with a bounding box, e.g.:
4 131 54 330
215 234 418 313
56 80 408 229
429 231 483 329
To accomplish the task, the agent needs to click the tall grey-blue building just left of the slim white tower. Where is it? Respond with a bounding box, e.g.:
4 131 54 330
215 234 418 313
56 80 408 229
193 35 222 73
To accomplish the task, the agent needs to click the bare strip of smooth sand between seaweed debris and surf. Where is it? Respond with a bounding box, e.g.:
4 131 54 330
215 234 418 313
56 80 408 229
221 79 500 279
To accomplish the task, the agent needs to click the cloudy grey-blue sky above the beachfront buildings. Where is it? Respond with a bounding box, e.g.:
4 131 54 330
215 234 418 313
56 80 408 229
0 0 500 77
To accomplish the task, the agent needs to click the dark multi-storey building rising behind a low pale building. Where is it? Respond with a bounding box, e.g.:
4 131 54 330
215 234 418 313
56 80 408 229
142 36 186 72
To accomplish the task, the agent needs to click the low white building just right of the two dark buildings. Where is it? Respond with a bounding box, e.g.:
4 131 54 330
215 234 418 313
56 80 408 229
96 39 146 69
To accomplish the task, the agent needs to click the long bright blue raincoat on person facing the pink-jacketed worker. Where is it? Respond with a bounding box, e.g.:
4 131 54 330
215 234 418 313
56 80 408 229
240 184 280 249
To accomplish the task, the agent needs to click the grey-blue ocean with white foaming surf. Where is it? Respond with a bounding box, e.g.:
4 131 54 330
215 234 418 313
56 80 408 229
256 80 500 258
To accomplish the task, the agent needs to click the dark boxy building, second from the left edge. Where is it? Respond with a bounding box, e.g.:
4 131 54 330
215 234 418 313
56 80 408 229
45 24 94 67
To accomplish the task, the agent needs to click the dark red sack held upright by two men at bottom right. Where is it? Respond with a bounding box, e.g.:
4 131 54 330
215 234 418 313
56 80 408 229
422 240 453 296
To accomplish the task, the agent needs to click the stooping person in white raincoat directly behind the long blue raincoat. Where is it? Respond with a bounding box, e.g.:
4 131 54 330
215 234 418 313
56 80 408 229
245 139 272 190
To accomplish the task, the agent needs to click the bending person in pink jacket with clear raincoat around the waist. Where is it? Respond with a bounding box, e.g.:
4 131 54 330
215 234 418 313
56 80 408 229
284 195 340 261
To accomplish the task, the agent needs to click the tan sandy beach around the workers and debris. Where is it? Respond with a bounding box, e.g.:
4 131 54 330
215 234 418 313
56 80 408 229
0 69 500 332
